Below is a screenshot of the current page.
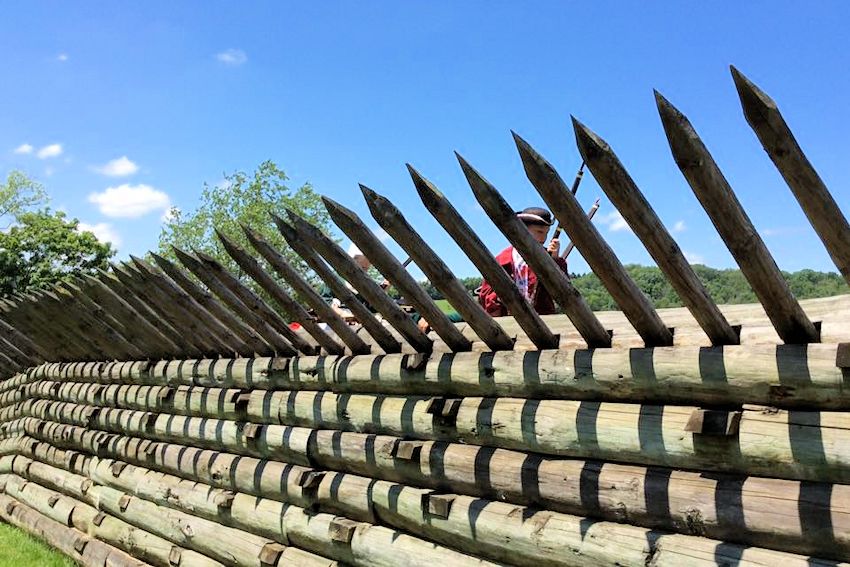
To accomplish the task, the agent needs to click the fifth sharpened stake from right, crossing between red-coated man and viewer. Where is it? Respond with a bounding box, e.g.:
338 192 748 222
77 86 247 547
455 154 611 348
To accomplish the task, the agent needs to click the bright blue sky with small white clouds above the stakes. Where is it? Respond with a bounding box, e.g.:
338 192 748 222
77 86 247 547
0 2 850 275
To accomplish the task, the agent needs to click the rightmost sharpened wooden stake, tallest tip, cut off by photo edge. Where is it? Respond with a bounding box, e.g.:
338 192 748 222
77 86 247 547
731 66 850 284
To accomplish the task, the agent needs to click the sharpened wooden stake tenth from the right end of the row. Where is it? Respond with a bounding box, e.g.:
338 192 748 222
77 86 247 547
272 214 401 353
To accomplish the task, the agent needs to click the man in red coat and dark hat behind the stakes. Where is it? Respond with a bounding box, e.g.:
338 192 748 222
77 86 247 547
478 207 567 317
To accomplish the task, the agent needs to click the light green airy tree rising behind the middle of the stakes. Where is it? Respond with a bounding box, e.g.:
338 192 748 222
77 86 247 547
159 161 329 290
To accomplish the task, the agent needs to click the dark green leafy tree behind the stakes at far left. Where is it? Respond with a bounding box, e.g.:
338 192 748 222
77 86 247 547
0 209 115 296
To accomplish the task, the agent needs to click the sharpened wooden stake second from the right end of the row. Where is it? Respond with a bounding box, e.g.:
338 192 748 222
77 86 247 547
655 92 819 343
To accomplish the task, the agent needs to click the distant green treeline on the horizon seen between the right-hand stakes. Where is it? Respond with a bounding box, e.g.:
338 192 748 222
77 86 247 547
422 265 850 311
